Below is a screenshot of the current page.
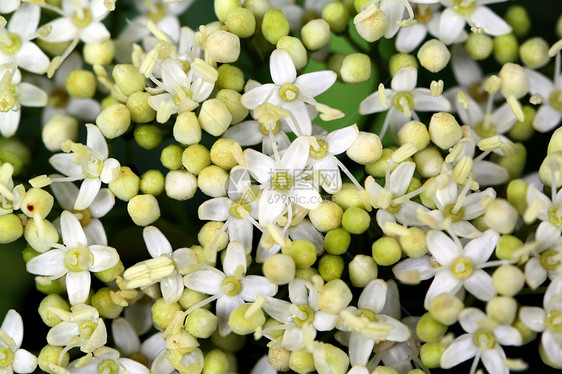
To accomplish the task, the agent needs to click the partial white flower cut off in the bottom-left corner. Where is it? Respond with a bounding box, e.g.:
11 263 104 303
0 309 37 374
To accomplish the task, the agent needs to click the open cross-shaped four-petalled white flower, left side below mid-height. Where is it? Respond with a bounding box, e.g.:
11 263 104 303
26 211 119 304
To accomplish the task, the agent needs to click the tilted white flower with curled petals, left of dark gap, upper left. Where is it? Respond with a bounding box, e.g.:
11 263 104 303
49 124 121 210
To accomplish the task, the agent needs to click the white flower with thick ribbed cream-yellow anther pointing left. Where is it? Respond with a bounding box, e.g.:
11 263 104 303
123 226 197 302
